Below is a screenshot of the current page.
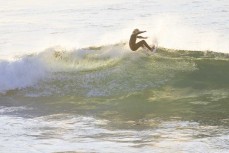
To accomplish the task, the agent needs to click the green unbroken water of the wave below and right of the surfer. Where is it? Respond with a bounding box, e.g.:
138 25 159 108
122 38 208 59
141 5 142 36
3 49 229 126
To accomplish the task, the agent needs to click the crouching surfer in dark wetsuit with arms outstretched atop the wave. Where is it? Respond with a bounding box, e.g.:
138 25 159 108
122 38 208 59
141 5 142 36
129 29 155 51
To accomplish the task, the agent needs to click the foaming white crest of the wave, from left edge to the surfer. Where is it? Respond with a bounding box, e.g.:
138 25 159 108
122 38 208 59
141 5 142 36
0 45 129 93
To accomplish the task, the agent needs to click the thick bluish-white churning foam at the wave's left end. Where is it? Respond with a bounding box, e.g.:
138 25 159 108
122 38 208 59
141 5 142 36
0 57 46 92
